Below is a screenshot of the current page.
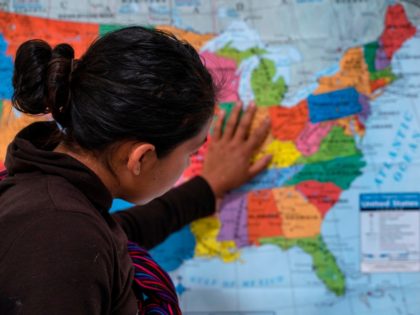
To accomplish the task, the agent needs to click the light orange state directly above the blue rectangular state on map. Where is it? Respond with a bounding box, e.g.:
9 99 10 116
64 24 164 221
314 47 371 95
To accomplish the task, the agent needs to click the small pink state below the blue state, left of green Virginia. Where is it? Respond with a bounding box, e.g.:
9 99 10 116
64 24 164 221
296 121 334 156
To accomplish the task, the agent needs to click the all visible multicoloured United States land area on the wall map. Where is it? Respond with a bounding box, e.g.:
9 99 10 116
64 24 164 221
0 4 416 302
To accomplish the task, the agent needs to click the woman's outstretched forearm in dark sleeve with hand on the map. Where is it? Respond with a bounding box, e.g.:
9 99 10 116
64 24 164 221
113 105 271 248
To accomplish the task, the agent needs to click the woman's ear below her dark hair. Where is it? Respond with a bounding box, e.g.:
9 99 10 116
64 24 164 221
127 143 157 176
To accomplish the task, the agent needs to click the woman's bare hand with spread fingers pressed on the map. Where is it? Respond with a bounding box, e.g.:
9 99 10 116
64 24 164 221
201 105 271 198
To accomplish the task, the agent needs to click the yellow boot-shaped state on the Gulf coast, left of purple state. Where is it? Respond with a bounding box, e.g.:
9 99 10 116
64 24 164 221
191 217 239 263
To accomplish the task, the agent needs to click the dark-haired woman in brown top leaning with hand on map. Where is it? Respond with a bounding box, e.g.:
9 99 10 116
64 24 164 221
0 27 269 315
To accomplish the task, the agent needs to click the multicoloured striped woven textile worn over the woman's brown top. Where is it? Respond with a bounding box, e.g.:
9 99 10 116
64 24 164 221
0 170 182 315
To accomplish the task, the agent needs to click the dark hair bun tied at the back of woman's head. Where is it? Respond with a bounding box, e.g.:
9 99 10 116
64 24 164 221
12 40 74 124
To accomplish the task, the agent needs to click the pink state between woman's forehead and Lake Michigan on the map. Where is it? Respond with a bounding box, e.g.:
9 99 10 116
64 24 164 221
200 51 239 102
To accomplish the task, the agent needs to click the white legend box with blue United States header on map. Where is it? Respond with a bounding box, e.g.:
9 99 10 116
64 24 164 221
359 193 420 273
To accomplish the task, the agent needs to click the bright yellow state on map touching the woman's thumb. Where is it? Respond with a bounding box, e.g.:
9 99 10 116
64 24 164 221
254 137 302 168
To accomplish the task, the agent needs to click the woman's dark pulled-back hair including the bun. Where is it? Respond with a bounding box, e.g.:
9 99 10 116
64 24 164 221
12 26 216 157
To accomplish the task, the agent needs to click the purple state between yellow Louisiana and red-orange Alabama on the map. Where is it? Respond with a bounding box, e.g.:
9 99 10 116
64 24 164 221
218 192 249 248
